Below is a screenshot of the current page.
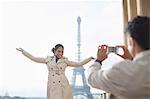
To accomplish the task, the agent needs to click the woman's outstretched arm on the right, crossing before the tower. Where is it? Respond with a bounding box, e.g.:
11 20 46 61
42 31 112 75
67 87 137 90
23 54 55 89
66 57 94 67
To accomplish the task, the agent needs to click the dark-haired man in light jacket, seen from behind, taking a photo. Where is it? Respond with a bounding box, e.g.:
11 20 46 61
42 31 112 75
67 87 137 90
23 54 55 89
88 16 150 99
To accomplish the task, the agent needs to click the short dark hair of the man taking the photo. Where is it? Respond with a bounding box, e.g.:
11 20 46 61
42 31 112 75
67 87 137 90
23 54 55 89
127 16 150 50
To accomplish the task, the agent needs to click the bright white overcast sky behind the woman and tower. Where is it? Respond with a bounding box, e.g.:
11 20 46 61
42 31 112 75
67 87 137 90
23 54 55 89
0 0 124 97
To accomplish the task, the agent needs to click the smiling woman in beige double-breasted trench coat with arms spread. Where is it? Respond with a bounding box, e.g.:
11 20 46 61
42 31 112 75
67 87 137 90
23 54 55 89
17 44 93 99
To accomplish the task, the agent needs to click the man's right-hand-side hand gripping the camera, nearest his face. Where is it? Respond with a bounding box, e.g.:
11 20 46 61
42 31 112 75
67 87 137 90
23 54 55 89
116 45 133 60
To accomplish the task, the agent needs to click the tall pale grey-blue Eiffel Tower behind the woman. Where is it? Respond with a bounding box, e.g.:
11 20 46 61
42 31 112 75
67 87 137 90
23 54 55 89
71 17 93 99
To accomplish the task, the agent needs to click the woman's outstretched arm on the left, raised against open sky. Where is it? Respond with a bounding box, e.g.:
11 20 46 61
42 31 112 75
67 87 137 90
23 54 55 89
16 48 46 63
